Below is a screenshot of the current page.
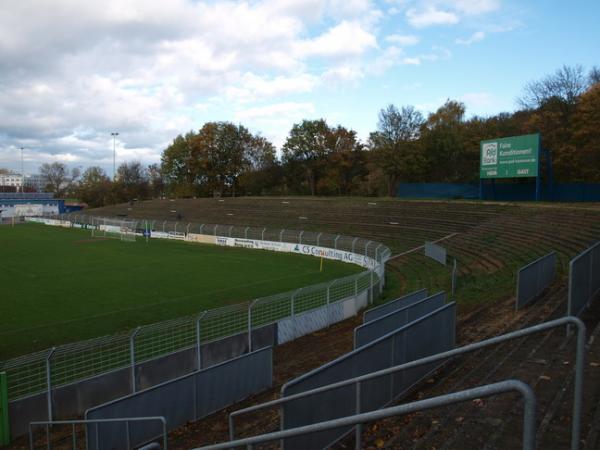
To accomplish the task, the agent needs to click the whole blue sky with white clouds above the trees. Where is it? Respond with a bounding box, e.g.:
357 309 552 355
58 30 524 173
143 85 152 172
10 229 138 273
0 0 600 175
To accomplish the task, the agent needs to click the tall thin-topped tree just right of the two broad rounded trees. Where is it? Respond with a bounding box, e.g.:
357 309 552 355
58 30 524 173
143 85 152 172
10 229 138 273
369 105 424 196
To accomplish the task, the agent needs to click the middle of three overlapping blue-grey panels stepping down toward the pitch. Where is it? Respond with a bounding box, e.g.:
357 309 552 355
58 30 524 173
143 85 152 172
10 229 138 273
354 292 446 349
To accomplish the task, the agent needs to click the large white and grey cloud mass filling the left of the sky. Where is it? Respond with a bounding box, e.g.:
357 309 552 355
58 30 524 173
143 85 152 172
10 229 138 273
0 0 390 169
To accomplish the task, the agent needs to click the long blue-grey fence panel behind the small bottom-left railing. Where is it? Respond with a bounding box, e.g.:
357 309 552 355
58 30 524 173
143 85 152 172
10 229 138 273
85 347 273 450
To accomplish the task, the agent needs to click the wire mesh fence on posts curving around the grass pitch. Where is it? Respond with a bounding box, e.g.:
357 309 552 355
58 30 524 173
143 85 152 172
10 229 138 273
0 214 391 401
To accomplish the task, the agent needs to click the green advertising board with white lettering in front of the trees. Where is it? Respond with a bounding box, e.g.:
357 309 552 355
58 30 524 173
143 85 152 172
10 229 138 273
479 134 540 178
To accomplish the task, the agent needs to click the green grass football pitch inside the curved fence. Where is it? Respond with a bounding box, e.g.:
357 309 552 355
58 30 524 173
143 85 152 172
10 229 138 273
0 224 362 360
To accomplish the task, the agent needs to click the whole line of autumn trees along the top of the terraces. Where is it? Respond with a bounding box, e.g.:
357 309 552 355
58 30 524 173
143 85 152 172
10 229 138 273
34 66 600 206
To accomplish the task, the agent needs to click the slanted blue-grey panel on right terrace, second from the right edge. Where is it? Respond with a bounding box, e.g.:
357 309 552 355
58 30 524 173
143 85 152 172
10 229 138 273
516 252 556 309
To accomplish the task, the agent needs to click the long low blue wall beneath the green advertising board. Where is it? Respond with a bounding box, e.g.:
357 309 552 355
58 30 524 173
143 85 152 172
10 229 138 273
396 181 600 202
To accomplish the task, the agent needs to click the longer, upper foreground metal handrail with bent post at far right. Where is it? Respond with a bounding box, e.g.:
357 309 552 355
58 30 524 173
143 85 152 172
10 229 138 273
229 316 586 450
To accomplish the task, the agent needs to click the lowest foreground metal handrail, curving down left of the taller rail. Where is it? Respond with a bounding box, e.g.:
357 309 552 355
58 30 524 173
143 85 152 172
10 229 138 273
194 380 536 450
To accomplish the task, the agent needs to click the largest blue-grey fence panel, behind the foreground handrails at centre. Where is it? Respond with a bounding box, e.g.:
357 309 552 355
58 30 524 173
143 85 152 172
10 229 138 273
282 303 456 450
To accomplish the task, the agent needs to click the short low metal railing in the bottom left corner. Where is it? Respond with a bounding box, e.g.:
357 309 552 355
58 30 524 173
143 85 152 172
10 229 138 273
29 416 167 450
